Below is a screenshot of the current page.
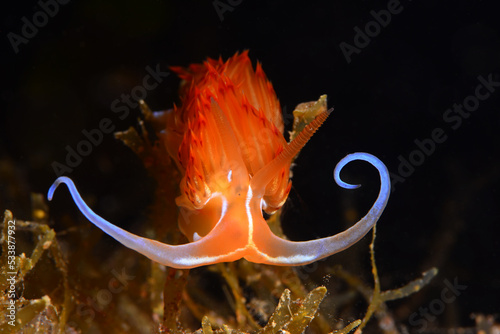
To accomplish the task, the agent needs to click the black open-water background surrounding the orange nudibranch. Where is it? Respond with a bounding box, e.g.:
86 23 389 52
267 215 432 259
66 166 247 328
0 0 500 326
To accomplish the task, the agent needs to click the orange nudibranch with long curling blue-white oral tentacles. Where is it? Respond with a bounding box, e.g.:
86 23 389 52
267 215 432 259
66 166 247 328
48 52 390 268
